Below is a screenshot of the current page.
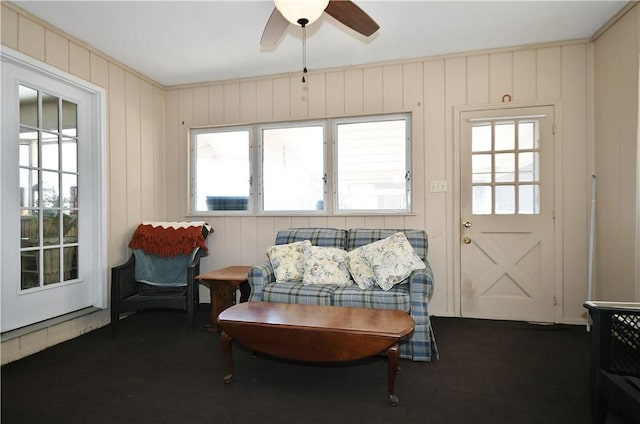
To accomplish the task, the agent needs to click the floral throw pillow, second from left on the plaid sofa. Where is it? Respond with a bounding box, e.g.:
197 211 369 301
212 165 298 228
302 246 351 286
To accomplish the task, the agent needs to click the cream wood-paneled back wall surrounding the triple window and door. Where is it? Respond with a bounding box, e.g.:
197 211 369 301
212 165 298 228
166 41 592 322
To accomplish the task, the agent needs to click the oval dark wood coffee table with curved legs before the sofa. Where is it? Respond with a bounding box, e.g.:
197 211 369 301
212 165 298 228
218 302 415 406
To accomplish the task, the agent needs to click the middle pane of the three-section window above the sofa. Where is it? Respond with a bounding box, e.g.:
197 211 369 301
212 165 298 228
262 125 325 211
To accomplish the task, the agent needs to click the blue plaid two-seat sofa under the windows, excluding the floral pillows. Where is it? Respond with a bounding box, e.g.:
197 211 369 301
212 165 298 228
249 228 438 361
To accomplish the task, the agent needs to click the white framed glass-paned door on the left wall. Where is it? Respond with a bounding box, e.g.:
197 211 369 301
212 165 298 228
0 48 105 331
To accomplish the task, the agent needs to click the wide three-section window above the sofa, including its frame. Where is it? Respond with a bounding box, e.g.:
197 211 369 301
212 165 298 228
191 114 411 214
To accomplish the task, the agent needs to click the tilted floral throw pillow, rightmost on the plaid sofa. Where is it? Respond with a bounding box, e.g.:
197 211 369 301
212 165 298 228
362 233 426 290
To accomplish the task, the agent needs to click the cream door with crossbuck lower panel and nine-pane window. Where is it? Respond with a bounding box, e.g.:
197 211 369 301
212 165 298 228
459 106 554 322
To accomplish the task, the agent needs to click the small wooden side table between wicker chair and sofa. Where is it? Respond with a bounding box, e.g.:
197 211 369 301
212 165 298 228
196 265 251 331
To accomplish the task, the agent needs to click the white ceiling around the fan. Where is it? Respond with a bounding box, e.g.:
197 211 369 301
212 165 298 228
13 0 627 86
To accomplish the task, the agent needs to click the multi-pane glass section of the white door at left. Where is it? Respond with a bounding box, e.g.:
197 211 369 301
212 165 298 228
18 85 79 290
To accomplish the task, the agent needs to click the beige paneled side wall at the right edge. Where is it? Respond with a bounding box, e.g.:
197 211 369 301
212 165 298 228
593 6 640 302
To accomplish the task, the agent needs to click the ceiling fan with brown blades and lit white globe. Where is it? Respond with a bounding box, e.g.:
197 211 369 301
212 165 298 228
260 0 380 47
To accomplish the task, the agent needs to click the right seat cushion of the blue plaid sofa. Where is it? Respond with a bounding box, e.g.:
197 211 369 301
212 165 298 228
333 284 411 312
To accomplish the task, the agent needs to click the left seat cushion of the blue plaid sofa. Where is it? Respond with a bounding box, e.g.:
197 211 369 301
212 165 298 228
262 281 338 306
